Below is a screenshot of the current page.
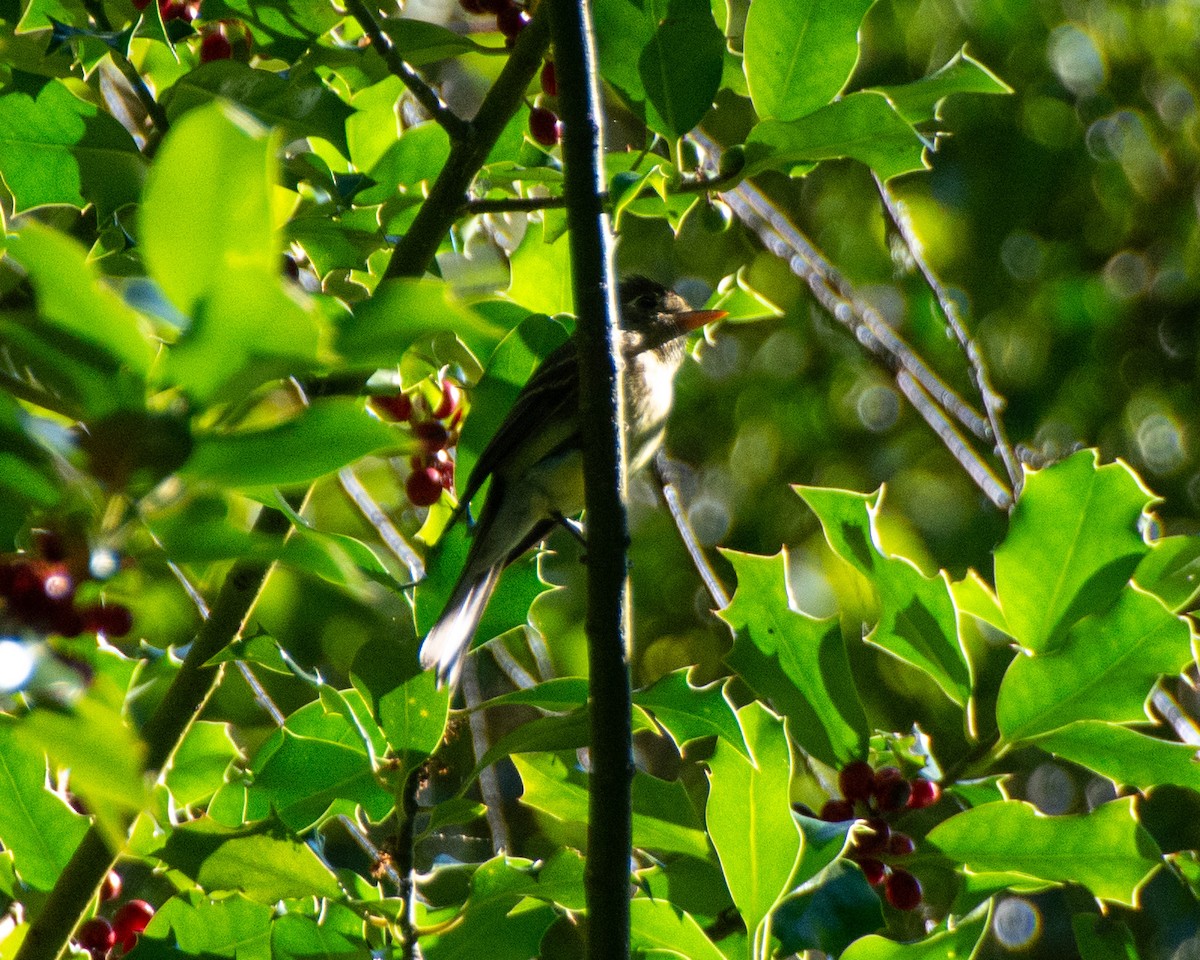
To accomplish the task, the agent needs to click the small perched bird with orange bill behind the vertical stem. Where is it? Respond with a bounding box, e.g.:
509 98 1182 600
421 276 725 686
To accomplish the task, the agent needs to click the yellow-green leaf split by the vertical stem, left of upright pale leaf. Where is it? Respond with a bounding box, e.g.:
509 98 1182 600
512 754 708 858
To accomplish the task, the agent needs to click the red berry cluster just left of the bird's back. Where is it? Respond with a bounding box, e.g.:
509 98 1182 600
371 380 462 506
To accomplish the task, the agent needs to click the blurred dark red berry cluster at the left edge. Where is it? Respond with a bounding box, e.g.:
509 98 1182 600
0 530 133 637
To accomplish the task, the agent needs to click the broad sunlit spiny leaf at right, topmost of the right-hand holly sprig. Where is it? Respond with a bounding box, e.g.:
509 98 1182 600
996 450 1154 653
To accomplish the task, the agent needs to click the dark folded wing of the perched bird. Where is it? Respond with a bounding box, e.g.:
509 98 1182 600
460 341 580 504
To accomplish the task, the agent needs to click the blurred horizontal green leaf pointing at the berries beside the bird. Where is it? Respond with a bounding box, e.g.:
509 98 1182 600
181 397 403 487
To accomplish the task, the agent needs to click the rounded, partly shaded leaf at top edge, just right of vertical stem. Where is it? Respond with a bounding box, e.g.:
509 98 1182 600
593 0 725 139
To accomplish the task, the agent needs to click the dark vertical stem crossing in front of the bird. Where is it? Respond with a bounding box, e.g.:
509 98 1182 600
551 0 634 960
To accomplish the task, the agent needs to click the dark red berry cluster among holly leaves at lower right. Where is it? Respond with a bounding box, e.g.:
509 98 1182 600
821 760 941 910
